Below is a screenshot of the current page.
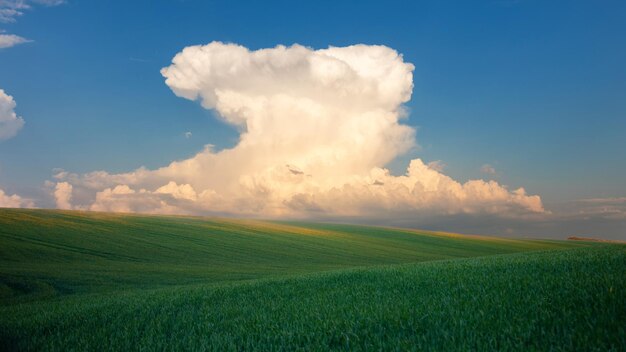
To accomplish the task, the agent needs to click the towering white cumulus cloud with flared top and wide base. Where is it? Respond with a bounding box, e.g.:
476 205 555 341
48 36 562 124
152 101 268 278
55 42 543 217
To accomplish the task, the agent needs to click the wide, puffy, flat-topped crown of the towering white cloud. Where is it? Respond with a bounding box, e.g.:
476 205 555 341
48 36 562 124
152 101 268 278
161 42 413 117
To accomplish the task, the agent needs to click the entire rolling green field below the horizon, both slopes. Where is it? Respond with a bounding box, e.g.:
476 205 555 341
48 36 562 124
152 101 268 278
0 209 626 351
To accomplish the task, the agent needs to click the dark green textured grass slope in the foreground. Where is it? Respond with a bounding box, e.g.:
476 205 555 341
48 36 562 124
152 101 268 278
0 245 626 351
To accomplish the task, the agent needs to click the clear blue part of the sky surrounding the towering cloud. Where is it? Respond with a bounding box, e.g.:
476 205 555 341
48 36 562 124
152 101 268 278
0 0 626 239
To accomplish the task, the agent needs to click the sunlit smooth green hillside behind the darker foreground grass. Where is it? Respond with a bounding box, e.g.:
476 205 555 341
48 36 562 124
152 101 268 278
0 209 581 305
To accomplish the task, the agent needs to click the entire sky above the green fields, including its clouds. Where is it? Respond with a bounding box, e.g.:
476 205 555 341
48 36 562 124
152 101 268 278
0 0 626 239
